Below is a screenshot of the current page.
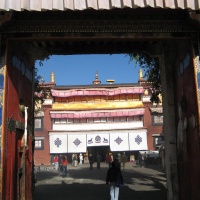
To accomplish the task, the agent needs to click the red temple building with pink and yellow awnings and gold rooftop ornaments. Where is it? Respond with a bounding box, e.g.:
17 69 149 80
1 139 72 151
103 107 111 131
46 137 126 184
34 70 163 165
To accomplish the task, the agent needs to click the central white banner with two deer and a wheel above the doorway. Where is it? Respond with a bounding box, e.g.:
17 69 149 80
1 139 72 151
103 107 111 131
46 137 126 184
87 133 110 147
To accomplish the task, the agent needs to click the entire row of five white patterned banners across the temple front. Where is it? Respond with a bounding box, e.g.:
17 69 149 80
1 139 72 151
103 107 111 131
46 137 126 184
49 129 148 154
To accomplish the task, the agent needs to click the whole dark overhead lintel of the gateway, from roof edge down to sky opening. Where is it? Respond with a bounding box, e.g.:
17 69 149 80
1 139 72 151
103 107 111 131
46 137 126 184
0 9 200 61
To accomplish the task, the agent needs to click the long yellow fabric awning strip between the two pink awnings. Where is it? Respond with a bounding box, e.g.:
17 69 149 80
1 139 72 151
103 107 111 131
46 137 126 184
52 101 144 110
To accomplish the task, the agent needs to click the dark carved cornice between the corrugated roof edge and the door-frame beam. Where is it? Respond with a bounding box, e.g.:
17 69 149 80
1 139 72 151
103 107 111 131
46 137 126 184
2 10 199 38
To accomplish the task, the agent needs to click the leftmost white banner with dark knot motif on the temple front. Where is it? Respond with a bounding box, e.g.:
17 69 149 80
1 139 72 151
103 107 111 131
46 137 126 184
49 134 67 154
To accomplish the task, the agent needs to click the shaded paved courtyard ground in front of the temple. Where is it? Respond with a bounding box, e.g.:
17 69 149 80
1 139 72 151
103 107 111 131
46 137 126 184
34 162 167 200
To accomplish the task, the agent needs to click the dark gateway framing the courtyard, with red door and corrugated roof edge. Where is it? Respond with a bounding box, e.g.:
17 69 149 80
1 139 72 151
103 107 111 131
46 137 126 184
0 0 200 200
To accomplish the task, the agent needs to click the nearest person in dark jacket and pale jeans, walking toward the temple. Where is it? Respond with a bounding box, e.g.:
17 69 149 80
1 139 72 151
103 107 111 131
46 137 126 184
106 162 123 200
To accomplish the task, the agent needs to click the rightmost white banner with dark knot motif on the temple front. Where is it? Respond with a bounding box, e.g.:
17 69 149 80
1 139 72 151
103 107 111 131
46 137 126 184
129 130 148 151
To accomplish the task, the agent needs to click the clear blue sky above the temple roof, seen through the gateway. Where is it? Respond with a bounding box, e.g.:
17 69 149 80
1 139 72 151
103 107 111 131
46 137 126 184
35 54 139 85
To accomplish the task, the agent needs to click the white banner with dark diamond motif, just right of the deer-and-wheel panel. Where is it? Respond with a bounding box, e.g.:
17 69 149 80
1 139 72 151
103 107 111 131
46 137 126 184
110 132 129 151
